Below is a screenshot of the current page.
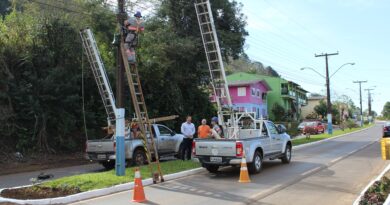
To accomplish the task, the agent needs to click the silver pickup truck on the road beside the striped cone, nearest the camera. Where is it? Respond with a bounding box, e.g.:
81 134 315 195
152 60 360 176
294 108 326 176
192 114 292 173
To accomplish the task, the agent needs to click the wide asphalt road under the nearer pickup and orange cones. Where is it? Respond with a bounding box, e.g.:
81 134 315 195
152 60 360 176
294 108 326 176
71 125 389 205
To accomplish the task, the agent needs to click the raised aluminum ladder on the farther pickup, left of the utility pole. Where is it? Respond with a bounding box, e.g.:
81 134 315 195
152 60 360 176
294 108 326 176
80 28 117 125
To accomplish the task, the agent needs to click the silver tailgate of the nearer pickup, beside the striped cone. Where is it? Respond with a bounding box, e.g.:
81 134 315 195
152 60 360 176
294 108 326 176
195 140 236 157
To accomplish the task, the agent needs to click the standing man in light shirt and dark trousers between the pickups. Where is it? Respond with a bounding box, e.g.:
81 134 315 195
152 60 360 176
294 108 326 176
180 116 195 160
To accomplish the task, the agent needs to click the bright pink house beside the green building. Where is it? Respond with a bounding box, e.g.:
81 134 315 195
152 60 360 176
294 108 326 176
211 80 271 117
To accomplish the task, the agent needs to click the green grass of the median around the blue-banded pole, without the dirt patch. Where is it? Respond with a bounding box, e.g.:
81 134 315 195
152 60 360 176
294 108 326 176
40 160 200 191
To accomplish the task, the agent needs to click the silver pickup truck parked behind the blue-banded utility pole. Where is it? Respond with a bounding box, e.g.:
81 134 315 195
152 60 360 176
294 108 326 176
86 124 184 169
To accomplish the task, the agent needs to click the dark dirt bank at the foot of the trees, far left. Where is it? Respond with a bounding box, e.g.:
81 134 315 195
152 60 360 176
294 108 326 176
0 153 89 175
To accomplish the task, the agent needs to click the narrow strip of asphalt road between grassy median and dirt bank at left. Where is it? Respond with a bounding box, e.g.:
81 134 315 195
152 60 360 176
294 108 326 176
0 163 103 189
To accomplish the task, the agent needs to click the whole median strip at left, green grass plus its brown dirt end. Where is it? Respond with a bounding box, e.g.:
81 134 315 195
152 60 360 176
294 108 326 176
1 160 200 199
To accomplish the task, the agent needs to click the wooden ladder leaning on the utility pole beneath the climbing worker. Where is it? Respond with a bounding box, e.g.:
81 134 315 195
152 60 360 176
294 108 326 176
120 41 164 183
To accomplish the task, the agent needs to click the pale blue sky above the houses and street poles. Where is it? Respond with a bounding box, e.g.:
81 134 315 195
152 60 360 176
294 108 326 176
238 0 390 113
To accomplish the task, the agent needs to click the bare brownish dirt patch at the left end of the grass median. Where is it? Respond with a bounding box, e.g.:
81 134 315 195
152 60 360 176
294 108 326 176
1 185 81 199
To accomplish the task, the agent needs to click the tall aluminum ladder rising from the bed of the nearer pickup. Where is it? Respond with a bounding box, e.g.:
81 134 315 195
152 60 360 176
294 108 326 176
195 0 234 138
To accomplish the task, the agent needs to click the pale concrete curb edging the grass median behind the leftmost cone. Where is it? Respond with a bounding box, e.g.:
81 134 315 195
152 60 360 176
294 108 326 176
0 167 204 205
